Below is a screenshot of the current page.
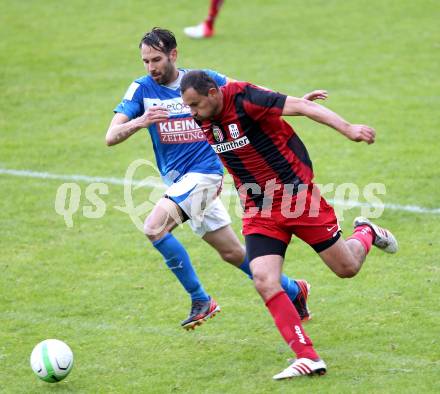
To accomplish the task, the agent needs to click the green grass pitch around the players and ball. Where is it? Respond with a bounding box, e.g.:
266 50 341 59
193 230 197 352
0 0 440 394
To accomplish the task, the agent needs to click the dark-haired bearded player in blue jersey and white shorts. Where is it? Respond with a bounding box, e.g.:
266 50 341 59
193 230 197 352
106 28 326 329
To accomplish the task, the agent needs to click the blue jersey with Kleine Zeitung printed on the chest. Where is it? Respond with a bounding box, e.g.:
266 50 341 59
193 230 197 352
114 69 226 184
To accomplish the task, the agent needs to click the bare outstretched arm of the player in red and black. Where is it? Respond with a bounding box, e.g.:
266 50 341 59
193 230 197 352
283 96 376 144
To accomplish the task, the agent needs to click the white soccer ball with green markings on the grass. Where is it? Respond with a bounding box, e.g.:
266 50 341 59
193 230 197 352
31 339 73 383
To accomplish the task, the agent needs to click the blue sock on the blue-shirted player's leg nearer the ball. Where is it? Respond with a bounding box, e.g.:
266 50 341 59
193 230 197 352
153 233 210 301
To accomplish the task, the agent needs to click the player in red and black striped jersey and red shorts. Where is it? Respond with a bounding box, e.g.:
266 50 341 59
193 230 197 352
181 71 397 379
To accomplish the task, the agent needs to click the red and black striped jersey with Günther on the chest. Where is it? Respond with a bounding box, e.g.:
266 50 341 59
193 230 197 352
200 82 313 208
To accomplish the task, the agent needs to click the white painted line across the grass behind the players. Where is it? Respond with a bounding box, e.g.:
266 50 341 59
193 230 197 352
0 168 440 215
